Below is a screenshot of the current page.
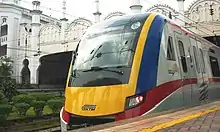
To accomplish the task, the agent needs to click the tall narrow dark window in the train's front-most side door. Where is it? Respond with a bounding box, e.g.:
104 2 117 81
178 41 187 72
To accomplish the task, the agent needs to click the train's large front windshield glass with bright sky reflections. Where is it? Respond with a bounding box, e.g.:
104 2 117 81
73 22 141 70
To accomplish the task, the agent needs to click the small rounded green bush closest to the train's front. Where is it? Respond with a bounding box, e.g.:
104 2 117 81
47 99 63 113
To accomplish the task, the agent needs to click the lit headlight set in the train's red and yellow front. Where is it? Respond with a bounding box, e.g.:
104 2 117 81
125 94 145 109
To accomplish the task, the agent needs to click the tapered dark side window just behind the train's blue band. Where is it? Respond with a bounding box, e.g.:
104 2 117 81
167 36 176 61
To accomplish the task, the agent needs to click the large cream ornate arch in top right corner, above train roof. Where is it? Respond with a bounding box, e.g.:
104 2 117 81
185 0 220 37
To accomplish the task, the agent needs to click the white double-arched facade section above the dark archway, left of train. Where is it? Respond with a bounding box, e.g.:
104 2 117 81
39 18 92 56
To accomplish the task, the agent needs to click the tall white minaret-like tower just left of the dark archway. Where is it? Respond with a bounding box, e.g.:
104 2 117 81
30 1 42 84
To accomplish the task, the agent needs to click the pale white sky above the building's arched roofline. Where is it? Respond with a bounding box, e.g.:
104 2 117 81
21 0 193 21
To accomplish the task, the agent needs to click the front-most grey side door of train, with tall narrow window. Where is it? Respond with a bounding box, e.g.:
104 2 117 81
174 31 191 106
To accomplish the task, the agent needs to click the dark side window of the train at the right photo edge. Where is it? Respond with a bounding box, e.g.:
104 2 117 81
209 56 220 77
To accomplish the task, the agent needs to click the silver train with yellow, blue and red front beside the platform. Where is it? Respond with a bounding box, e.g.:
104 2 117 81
60 12 220 129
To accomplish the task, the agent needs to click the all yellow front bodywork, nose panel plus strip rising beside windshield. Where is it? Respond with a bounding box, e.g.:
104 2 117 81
65 14 156 116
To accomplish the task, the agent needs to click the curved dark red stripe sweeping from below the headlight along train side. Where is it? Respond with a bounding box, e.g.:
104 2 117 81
115 78 197 121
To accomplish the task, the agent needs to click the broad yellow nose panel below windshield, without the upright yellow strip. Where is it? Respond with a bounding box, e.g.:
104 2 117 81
65 85 132 116
